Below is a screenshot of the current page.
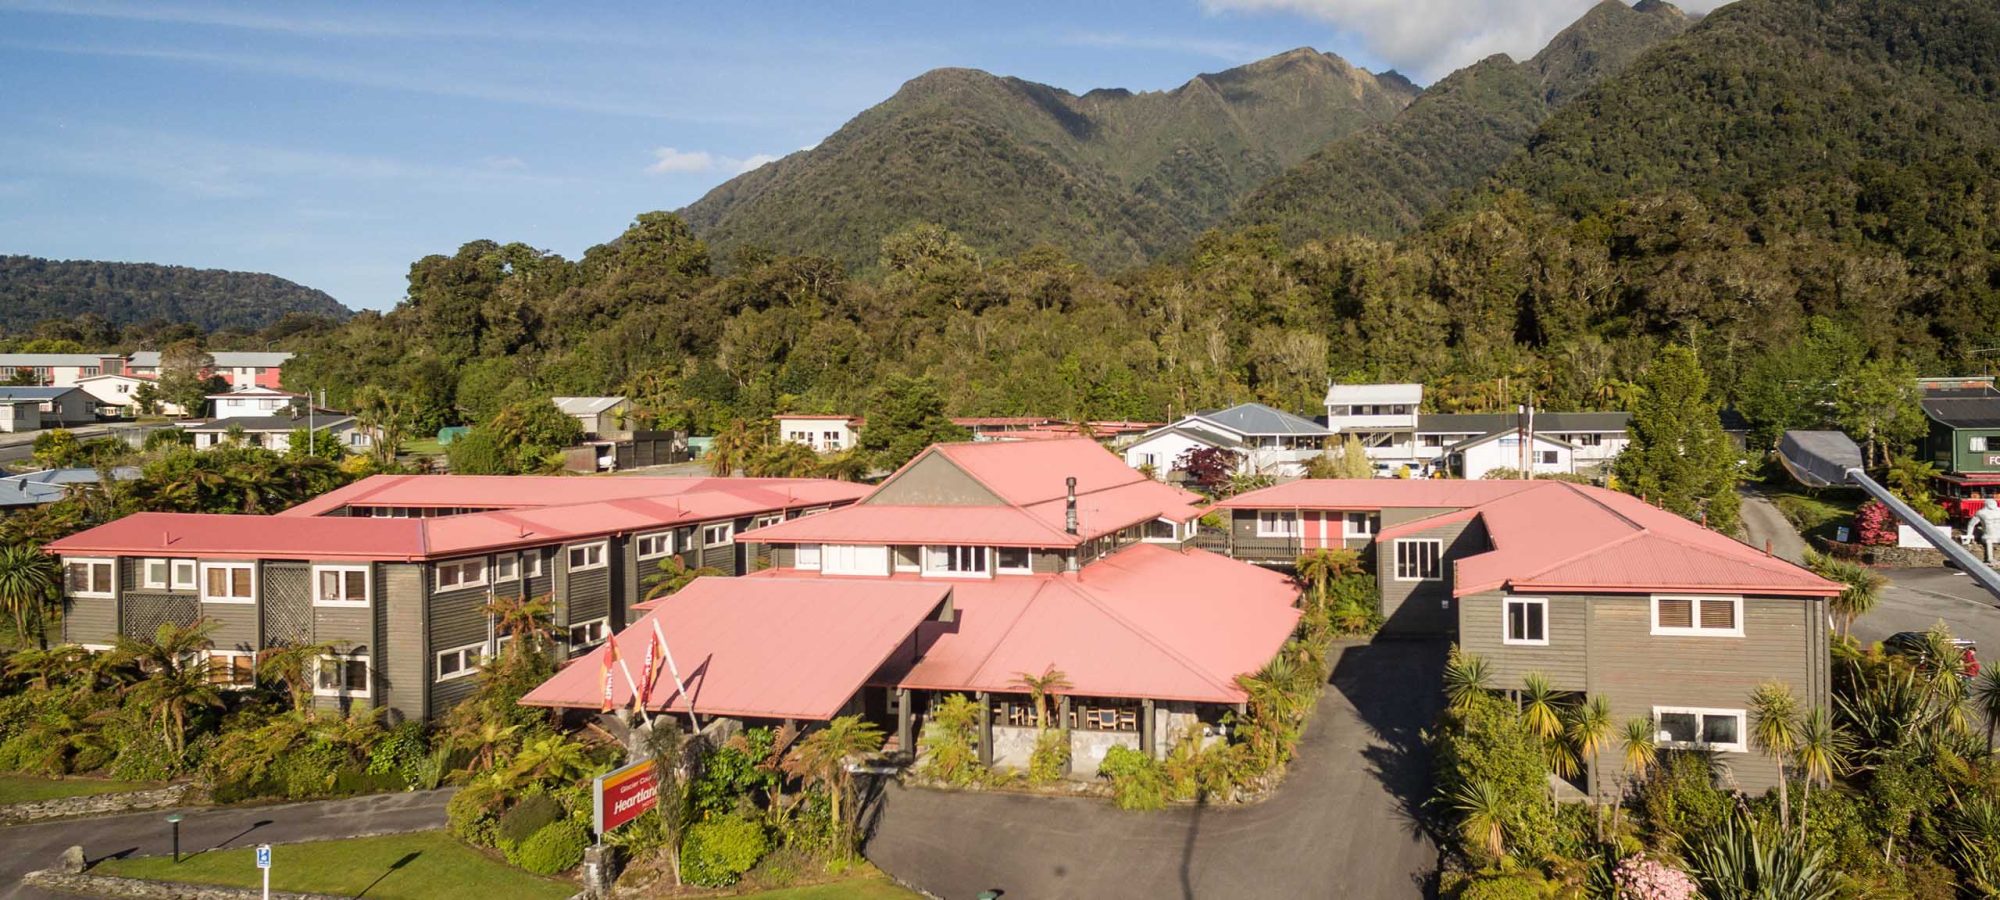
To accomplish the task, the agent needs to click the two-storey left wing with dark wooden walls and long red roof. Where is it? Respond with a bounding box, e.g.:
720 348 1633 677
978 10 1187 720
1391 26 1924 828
46 476 864 718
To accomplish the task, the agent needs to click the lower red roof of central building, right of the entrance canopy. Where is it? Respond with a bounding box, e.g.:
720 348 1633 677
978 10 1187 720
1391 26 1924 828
820 544 1298 704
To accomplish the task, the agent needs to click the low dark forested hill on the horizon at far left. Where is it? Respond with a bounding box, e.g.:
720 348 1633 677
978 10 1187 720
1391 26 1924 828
0 256 352 332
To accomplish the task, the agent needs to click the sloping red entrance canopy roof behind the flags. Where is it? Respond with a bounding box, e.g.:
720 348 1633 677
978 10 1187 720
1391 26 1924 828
522 578 954 722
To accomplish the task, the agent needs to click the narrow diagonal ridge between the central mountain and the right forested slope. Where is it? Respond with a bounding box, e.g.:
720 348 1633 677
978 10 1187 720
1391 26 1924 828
1230 0 1688 244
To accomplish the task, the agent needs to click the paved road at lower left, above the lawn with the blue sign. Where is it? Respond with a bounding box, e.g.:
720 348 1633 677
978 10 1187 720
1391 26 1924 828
0 788 452 900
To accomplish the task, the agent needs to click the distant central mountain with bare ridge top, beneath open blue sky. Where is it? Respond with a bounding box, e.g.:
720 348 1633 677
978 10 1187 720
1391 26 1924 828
682 50 1416 268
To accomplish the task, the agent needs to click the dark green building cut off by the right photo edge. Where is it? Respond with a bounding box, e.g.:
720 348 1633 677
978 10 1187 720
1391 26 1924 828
1918 378 2000 520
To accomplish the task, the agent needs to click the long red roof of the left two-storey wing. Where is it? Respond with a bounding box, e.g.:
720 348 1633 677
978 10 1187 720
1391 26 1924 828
48 476 868 560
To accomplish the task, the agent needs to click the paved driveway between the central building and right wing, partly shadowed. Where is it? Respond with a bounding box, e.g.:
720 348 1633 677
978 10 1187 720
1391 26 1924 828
866 642 1444 900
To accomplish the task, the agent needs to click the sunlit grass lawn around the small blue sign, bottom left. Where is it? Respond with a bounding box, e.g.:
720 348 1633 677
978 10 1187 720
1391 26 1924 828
92 832 576 900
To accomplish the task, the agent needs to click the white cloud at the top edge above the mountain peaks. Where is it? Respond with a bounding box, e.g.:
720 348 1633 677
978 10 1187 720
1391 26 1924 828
1202 0 1726 82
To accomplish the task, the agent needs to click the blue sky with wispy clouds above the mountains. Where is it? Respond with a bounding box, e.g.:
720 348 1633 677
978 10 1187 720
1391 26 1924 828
0 0 1706 308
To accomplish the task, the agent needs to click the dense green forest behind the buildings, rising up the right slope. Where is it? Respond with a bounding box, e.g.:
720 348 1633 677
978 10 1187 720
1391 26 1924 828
286 0 2000 450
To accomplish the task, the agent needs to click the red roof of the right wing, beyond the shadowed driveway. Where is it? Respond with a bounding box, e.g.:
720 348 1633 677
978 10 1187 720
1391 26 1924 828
1218 478 1840 596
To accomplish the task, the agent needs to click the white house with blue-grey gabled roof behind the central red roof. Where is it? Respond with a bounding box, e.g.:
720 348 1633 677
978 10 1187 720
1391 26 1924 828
1124 404 1332 480
